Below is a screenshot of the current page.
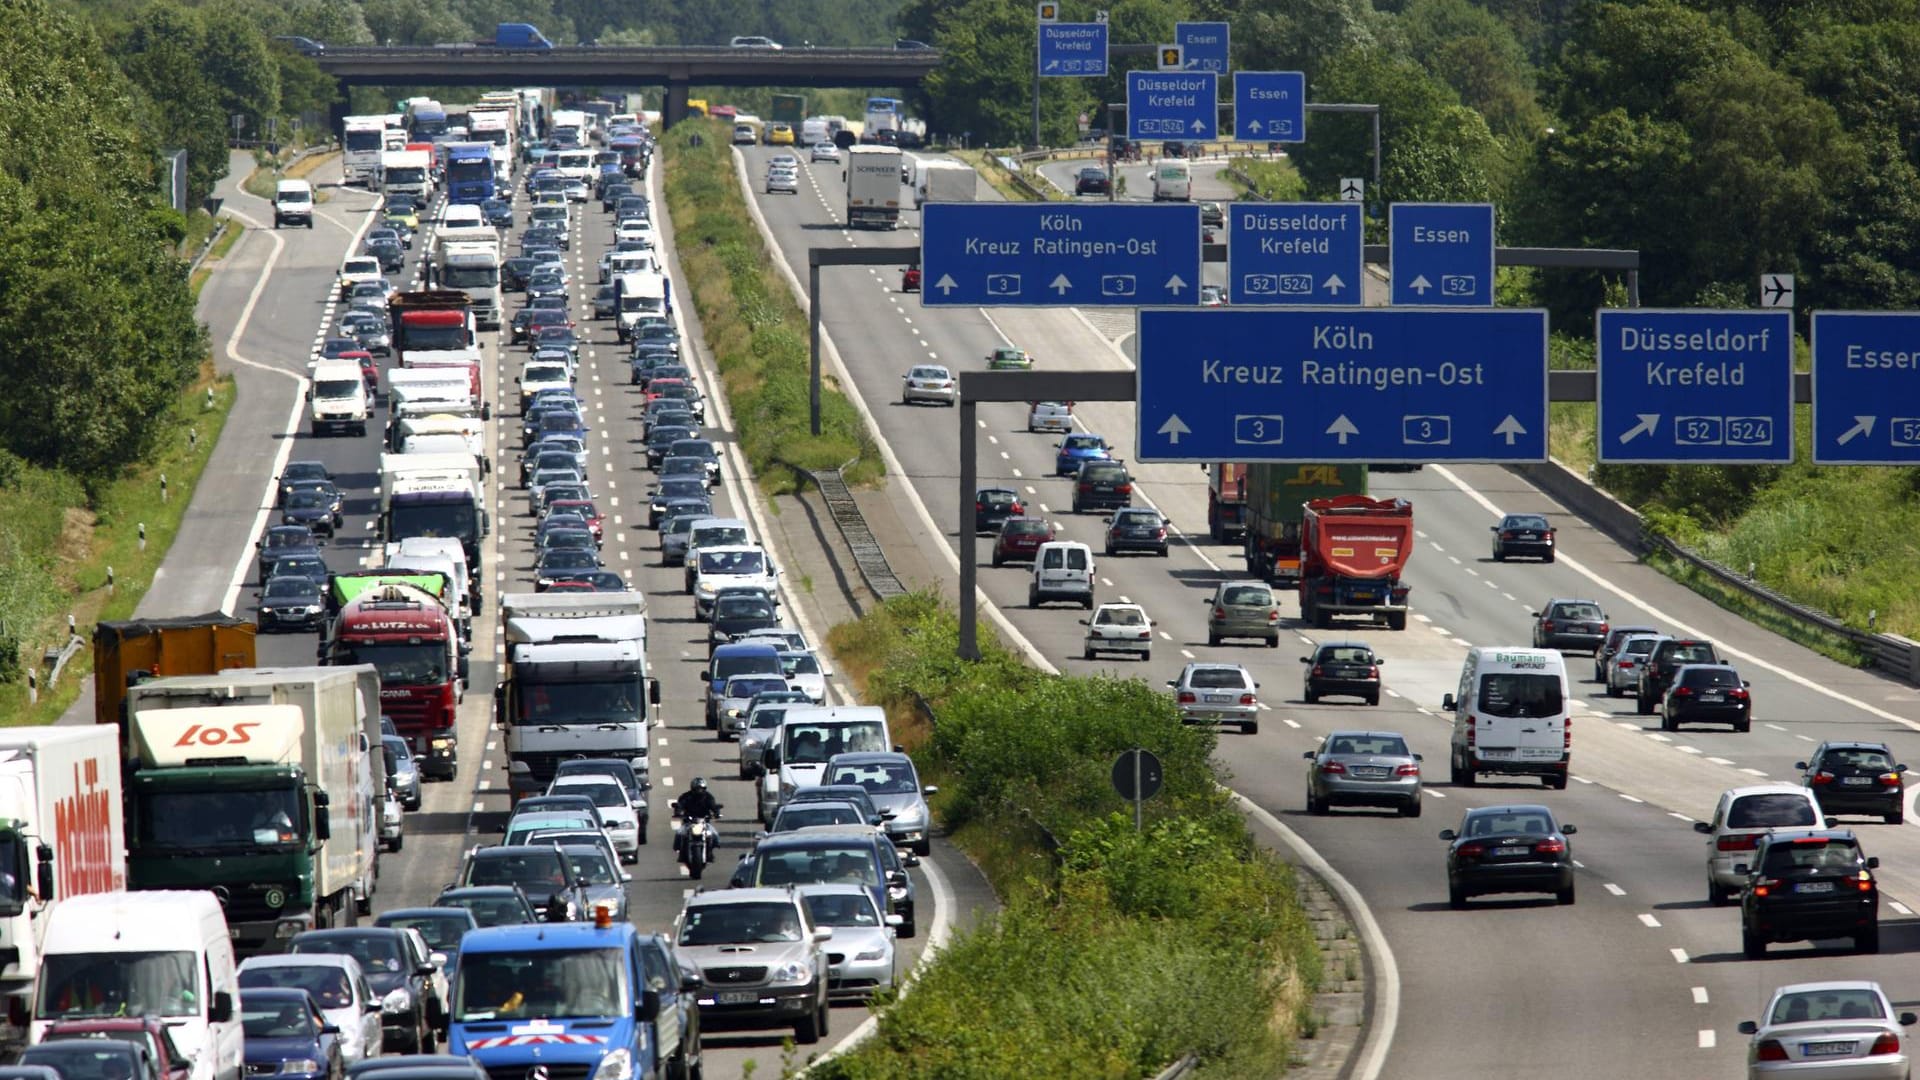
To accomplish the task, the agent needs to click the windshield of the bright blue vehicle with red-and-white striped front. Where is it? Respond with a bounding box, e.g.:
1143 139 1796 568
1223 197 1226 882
453 949 632 1022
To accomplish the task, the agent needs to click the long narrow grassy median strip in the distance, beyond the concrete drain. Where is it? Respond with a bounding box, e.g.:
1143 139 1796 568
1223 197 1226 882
660 121 885 494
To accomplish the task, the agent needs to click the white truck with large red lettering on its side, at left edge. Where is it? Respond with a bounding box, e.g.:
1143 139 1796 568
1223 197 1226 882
0 724 127 1043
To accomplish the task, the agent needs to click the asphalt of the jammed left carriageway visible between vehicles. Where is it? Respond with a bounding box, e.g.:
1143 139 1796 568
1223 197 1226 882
142 145 991 1080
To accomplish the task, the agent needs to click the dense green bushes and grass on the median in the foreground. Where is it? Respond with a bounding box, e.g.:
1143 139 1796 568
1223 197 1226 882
812 594 1321 1080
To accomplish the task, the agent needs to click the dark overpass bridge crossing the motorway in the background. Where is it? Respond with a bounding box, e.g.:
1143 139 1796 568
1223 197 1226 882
309 44 941 127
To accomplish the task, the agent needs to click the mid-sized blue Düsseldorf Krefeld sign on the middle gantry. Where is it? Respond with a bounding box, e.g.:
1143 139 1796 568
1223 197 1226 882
1227 202 1365 307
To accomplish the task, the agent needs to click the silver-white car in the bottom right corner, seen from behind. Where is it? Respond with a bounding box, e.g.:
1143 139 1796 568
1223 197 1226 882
1735 976 1916 1080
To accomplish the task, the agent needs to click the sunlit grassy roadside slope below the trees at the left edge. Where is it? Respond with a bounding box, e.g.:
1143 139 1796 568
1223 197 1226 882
0 359 234 726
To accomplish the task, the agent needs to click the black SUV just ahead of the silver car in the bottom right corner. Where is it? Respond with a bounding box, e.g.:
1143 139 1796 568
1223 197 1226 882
1734 830 1880 959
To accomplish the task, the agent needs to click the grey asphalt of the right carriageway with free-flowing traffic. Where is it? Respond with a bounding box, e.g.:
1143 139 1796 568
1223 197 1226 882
741 138 1920 1080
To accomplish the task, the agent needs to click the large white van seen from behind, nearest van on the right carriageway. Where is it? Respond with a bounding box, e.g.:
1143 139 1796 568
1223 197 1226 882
1440 646 1572 788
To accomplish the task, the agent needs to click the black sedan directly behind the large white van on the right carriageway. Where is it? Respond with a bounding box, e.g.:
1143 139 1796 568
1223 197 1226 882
1440 805 1576 907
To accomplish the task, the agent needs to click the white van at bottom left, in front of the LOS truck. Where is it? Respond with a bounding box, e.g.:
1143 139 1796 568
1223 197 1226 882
29 892 242 1080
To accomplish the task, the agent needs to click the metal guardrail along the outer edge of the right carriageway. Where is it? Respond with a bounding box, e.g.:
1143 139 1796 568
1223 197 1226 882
1509 461 1920 686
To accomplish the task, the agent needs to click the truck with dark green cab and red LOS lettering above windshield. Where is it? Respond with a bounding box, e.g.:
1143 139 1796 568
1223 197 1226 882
127 665 386 955
